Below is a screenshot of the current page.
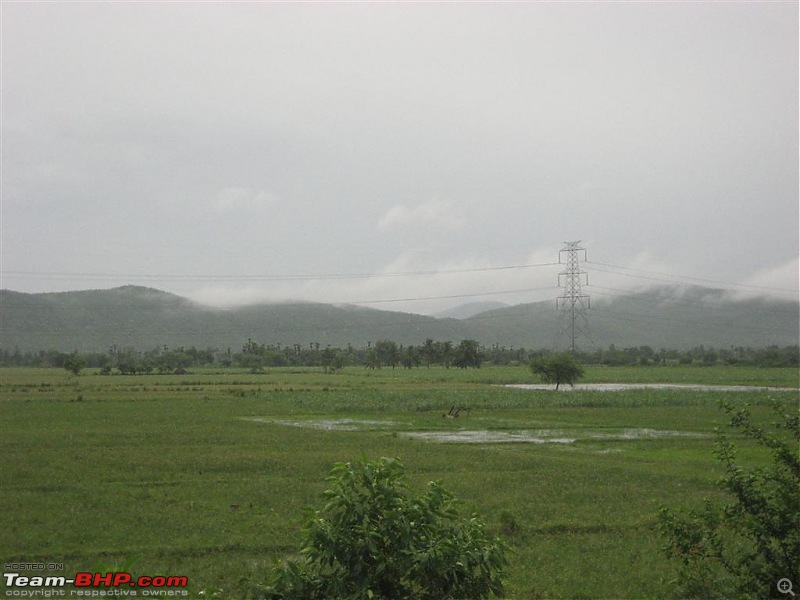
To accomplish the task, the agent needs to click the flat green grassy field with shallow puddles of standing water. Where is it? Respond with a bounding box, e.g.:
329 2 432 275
0 367 798 598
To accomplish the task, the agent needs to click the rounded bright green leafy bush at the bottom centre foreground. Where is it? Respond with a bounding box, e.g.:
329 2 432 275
254 458 507 600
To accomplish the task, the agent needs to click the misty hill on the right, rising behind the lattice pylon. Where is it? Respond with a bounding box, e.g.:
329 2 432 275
466 285 800 349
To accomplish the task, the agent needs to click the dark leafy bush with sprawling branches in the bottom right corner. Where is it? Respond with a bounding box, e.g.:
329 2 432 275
660 402 800 598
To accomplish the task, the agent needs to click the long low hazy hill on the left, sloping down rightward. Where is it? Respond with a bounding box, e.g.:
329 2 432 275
0 286 465 352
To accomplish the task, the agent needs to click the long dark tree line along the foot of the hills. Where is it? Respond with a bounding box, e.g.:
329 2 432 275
0 338 800 374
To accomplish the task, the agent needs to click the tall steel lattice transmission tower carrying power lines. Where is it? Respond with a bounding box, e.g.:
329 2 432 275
556 240 592 353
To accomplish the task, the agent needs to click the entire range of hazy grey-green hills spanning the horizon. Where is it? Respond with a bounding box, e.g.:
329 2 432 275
0 286 800 352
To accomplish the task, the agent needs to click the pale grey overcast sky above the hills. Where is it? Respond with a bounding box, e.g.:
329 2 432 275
0 1 798 313
